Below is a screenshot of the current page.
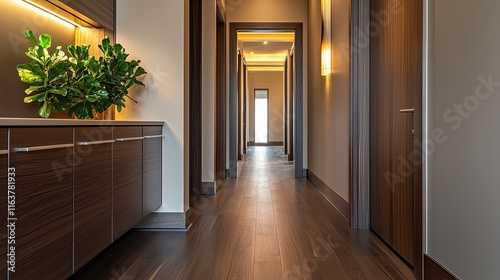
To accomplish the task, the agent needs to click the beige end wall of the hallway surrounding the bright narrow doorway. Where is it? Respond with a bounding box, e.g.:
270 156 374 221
248 71 284 142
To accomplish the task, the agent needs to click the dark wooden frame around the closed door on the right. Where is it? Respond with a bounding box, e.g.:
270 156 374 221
349 0 428 279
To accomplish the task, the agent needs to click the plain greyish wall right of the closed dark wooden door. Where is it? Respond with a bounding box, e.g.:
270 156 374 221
427 0 500 280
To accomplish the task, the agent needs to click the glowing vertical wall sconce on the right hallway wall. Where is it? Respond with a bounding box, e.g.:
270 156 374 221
321 0 332 76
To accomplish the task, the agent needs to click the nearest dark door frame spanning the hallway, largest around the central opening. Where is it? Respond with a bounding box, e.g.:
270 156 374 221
228 22 305 178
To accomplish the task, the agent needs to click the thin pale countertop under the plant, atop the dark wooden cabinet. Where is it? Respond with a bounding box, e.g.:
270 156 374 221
0 118 165 127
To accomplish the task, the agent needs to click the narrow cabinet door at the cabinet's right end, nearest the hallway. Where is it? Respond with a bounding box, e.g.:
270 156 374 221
142 126 162 217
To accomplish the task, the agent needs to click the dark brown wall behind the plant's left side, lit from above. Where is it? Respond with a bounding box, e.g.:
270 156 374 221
0 0 74 118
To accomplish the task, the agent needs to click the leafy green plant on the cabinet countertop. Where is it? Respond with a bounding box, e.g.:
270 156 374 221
17 30 147 119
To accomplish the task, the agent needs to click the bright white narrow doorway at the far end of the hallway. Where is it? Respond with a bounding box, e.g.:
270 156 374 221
254 89 269 144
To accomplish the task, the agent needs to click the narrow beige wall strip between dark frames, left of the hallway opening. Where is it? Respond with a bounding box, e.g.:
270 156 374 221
201 0 217 182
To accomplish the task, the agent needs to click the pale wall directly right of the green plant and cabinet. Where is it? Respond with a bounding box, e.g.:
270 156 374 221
116 0 188 212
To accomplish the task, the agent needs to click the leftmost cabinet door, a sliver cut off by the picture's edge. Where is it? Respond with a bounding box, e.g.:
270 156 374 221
0 128 7 279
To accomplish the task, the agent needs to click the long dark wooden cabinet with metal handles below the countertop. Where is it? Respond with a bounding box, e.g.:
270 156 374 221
0 121 162 280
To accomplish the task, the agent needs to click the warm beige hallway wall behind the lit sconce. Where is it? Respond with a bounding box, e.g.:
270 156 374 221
308 0 351 201
